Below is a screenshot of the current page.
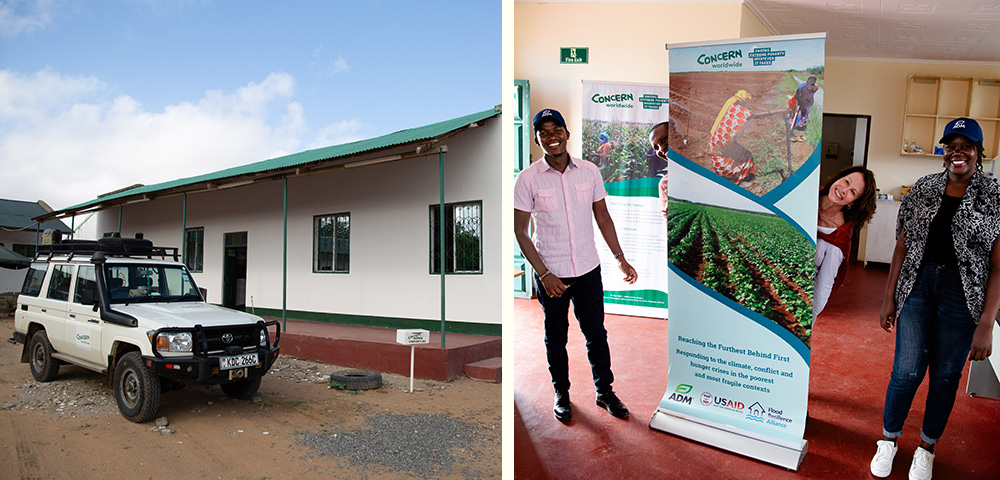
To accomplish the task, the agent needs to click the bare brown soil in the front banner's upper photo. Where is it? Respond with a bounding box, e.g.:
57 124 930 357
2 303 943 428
670 72 816 196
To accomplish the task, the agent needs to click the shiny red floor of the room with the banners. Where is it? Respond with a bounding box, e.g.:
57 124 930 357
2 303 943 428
507 265 1000 480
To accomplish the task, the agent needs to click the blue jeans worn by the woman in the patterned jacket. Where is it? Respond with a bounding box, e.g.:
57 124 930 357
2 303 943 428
882 264 976 445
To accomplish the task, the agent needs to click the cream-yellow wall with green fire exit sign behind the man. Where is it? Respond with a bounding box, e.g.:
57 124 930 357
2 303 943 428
514 3 743 158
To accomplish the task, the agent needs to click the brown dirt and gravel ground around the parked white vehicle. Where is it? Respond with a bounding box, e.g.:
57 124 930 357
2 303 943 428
0 315 501 480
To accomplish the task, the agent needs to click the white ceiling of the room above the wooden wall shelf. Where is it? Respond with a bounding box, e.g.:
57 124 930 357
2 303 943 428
743 0 1000 65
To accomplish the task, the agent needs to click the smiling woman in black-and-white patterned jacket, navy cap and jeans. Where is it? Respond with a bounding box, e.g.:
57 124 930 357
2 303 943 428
871 118 1000 479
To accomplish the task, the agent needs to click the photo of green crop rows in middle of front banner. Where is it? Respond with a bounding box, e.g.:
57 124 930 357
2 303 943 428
667 167 816 347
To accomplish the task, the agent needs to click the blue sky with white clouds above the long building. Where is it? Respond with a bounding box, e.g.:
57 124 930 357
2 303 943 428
0 0 502 209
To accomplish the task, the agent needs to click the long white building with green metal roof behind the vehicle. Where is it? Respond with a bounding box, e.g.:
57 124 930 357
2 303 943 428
36 106 509 336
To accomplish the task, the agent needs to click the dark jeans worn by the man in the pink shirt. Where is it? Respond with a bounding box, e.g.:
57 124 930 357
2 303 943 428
535 266 615 394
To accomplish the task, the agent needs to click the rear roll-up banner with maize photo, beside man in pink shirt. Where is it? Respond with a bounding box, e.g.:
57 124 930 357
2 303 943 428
577 81 669 318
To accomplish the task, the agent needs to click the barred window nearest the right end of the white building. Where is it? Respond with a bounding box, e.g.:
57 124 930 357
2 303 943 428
430 201 483 273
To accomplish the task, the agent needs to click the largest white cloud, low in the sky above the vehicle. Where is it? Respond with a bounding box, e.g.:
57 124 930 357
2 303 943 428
0 70 314 209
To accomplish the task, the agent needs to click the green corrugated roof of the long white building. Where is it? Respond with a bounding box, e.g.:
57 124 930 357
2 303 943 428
45 106 500 217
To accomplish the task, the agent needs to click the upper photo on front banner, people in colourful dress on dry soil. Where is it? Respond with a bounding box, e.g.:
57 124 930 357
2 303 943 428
670 66 823 196
